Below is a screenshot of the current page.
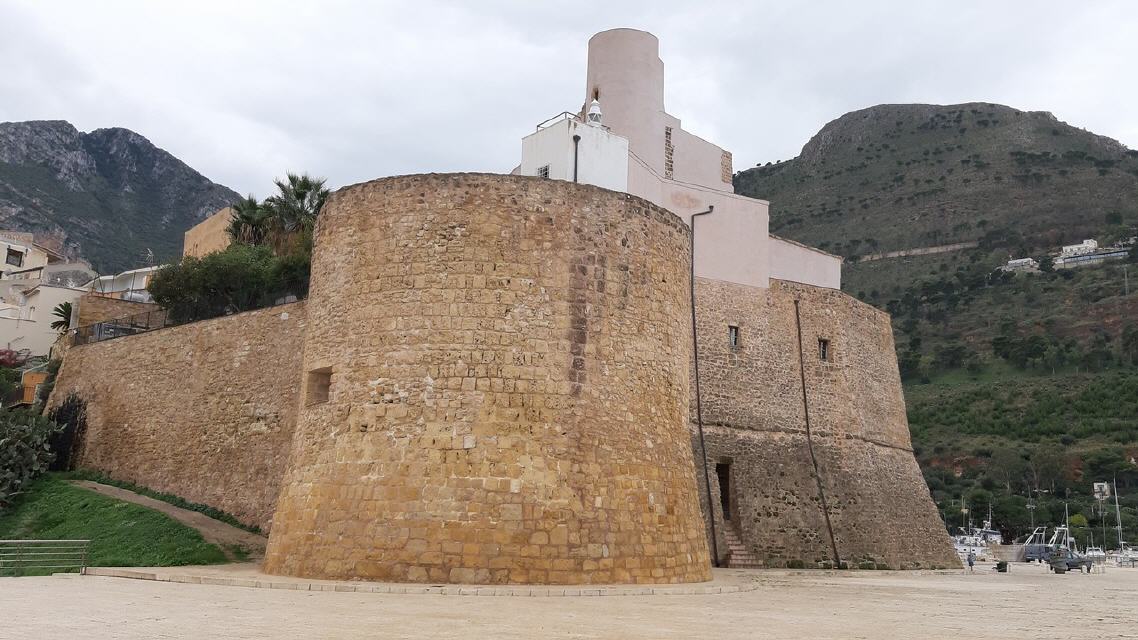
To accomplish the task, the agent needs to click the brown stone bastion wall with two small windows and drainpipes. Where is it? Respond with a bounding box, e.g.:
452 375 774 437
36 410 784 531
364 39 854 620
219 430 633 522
692 278 959 568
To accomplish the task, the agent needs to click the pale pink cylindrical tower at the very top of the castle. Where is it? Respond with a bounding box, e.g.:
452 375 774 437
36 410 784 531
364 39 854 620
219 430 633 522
585 28 665 175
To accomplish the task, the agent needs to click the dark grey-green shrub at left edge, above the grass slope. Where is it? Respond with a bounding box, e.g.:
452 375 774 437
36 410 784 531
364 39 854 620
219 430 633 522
0 411 59 508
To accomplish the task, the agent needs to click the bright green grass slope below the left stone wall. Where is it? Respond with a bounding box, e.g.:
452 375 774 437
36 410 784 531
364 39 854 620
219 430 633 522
0 474 225 567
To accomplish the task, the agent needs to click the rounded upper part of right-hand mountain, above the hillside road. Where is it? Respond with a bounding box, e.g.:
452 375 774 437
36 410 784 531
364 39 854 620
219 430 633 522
735 102 1138 257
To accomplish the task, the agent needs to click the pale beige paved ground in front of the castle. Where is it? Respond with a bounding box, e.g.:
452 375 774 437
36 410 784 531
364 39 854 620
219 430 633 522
0 565 1138 640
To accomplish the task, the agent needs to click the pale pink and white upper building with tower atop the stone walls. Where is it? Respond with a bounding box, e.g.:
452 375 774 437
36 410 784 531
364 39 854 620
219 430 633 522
514 28 841 289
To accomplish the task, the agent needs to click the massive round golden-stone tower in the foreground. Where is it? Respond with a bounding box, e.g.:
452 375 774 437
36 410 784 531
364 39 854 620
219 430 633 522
265 174 710 583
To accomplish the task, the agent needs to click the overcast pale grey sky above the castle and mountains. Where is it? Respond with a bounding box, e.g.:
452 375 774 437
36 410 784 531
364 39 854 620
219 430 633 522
0 0 1138 196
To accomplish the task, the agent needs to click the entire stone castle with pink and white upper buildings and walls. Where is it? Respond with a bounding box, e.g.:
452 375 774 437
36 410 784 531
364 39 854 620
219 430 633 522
50 30 958 583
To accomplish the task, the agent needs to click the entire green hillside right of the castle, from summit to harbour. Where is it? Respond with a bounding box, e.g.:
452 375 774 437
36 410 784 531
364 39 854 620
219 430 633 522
735 102 1138 542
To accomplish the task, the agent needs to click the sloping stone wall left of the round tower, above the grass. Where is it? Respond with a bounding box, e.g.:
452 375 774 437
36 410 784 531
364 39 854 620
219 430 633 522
49 297 306 530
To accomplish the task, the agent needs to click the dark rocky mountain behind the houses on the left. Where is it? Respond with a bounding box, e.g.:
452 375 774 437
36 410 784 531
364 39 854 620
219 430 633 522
0 121 239 273
